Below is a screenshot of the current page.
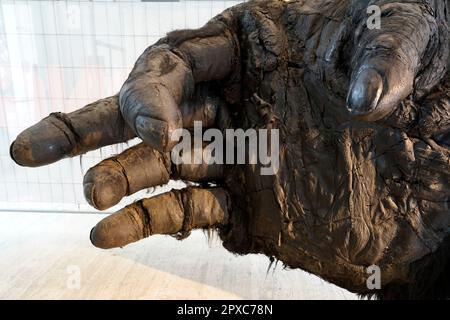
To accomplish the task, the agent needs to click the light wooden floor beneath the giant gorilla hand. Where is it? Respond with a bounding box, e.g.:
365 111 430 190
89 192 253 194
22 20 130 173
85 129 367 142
0 212 356 299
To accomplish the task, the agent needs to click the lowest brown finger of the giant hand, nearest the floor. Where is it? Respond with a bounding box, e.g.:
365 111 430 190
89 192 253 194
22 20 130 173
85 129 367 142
91 188 230 249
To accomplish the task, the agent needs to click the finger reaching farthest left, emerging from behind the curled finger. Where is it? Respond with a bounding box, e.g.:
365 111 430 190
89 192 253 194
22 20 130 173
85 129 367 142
10 96 134 167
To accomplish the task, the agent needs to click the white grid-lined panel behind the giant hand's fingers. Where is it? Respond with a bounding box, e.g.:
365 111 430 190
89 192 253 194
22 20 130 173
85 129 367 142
0 0 242 212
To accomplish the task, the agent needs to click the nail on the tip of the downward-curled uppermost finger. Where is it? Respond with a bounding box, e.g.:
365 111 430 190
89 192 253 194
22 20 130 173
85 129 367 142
134 116 167 152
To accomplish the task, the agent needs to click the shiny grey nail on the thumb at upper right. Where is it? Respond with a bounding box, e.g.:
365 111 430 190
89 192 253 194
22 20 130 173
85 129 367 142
347 68 383 116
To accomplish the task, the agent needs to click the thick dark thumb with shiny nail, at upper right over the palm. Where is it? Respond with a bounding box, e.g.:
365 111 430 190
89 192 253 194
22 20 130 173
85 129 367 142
347 3 435 121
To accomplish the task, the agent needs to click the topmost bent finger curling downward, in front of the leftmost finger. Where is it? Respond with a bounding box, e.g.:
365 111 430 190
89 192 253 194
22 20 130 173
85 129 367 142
119 21 236 151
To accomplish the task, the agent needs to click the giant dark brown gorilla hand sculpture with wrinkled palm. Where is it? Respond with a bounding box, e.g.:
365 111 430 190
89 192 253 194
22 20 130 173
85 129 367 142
11 0 450 298
